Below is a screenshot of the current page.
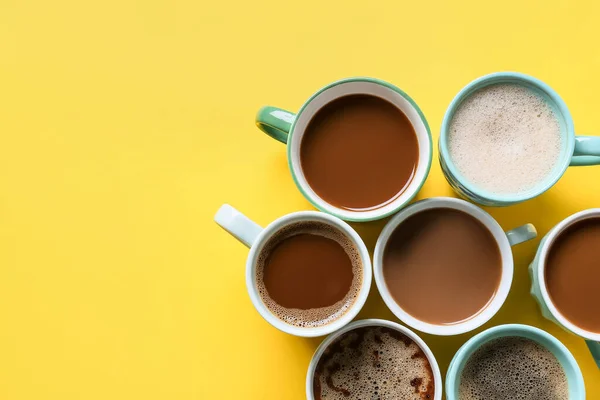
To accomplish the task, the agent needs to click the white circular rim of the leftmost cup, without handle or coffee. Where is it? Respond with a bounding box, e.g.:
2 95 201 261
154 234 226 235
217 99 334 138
246 211 372 337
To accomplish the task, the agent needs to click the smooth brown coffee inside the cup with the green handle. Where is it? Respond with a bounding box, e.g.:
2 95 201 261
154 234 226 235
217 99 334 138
300 95 419 210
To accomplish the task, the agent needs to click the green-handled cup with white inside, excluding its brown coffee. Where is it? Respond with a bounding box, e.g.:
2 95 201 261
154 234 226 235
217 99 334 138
256 77 432 222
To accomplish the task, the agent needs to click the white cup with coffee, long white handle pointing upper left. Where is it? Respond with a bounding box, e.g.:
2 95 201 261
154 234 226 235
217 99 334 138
215 204 371 337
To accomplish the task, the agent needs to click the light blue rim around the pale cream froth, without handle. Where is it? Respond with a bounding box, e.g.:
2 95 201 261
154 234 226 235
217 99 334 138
439 72 575 204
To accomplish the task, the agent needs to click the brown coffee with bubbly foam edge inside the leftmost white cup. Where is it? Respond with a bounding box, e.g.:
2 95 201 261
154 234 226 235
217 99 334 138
257 222 362 327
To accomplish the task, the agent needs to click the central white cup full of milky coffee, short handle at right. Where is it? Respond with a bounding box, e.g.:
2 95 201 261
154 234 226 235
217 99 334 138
373 197 536 335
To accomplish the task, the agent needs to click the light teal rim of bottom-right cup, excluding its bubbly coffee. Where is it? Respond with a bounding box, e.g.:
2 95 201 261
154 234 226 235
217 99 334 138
446 324 585 400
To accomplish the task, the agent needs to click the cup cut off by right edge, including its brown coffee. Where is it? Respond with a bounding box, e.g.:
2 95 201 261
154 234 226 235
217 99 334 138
529 208 600 368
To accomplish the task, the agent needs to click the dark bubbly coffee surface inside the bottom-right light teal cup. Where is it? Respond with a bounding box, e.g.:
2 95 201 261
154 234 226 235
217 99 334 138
459 337 569 400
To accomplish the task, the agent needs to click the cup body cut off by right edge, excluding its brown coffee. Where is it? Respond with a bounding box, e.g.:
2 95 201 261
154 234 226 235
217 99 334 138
529 208 600 368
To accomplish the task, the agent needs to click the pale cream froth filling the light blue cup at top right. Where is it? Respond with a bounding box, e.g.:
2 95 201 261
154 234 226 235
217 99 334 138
448 84 562 194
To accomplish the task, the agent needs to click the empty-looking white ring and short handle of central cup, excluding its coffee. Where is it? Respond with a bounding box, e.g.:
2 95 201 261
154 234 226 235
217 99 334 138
373 197 537 336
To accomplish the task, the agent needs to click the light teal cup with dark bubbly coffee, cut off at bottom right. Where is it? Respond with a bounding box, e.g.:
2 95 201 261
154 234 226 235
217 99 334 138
446 324 585 400
